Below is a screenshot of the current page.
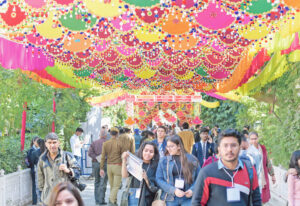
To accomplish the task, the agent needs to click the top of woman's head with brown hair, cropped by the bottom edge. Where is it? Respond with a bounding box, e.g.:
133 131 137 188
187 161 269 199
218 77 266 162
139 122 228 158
48 182 84 206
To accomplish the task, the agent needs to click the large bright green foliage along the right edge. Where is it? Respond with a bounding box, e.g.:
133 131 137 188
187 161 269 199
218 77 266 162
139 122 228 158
237 64 300 167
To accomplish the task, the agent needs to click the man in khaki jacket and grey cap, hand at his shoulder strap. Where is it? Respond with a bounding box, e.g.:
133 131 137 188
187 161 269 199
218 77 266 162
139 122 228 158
38 133 80 205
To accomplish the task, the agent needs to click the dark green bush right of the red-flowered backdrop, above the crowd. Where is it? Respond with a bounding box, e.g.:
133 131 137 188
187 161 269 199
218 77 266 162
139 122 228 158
201 94 243 129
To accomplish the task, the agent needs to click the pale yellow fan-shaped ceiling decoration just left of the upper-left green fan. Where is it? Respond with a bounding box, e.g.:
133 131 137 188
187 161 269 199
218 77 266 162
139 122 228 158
36 12 63 39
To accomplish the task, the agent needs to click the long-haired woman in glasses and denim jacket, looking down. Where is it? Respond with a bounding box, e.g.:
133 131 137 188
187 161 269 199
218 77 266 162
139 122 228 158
156 135 200 206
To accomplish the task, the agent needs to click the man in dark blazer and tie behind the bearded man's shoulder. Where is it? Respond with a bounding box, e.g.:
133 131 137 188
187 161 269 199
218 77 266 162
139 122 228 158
192 127 214 167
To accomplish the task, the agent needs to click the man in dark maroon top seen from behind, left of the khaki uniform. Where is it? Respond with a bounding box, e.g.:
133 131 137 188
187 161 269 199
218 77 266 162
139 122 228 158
88 132 107 205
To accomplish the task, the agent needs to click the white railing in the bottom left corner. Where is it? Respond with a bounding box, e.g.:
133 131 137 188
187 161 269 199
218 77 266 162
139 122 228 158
0 166 32 206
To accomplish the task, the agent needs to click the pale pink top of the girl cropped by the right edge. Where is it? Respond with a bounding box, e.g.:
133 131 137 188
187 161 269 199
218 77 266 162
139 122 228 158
288 175 300 206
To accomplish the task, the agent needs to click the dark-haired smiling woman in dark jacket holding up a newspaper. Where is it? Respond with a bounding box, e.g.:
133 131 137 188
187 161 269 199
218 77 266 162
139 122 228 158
122 142 159 206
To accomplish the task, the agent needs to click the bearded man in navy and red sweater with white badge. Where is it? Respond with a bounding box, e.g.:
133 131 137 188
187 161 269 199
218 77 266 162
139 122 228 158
192 129 262 206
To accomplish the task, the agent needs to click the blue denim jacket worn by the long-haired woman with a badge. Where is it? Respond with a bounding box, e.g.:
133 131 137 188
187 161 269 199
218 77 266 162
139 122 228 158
156 153 200 201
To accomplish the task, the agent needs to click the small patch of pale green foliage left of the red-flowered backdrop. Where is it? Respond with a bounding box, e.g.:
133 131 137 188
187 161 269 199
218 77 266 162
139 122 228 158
103 102 127 126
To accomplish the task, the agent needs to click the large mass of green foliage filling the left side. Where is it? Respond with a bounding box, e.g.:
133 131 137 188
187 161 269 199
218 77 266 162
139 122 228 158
0 68 95 171
